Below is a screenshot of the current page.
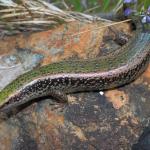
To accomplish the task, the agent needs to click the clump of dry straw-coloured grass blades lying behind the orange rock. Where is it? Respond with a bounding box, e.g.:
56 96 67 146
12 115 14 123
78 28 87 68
0 0 110 35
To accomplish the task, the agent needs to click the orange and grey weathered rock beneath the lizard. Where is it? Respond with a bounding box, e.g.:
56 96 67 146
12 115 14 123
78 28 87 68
0 20 150 150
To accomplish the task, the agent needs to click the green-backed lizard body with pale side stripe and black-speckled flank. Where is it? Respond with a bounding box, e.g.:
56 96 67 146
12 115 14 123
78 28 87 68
0 32 150 115
